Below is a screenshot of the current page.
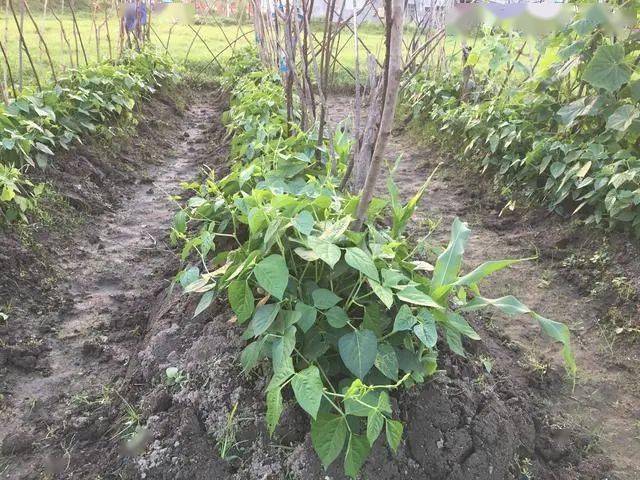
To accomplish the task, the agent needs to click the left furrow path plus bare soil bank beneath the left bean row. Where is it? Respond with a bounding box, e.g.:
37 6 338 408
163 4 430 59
0 85 230 478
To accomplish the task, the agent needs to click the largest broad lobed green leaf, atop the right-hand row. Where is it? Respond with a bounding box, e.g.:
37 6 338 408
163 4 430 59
582 43 631 93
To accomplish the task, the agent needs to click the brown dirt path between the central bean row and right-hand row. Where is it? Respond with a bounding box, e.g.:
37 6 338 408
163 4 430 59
332 97 640 480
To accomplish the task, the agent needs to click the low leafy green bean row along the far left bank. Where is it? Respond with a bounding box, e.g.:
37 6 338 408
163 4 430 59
0 52 175 223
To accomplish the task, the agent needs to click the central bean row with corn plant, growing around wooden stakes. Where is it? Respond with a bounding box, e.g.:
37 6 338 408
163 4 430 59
171 48 575 477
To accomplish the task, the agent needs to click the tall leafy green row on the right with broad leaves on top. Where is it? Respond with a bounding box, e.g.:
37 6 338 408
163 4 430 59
405 15 640 233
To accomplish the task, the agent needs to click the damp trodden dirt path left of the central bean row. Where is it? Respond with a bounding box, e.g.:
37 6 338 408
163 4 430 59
0 89 223 478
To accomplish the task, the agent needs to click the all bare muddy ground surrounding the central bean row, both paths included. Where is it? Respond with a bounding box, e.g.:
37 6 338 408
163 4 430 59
0 88 640 480
